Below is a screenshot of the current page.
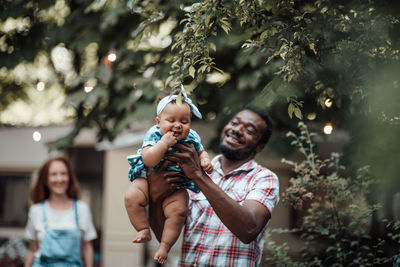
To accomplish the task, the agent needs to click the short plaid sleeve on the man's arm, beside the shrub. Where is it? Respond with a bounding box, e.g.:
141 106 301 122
246 169 279 214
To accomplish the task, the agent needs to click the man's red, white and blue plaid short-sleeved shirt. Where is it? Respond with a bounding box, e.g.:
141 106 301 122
179 156 279 267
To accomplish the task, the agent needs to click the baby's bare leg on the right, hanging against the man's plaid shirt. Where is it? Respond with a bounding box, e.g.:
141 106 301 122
154 189 189 264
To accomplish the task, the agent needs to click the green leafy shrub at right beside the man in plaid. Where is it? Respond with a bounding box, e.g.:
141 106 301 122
265 122 400 266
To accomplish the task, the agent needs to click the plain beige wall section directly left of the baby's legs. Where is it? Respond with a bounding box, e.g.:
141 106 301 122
101 148 144 267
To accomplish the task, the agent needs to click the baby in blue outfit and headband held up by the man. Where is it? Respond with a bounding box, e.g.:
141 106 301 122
125 86 213 264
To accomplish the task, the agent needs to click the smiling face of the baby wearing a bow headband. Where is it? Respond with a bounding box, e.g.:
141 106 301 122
156 102 190 140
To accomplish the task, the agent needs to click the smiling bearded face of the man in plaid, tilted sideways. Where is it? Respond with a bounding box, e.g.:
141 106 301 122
219 110 267 160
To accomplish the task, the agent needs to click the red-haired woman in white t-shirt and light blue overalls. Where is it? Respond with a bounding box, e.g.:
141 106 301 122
24 157 97 267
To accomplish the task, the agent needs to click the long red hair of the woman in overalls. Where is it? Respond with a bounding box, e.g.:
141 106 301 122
31 157 80 204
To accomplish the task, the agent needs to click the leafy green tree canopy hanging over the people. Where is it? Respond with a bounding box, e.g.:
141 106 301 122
0 0 400 191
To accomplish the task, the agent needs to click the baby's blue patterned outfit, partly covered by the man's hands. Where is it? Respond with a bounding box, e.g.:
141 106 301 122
127 125 204 193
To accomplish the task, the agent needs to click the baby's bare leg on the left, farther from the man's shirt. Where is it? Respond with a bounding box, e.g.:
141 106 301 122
125 178 151 243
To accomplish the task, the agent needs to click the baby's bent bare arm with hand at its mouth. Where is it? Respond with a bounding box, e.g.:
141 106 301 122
142 132 178 168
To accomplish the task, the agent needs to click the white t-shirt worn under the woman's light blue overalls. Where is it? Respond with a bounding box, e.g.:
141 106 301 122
25 200 97 257
